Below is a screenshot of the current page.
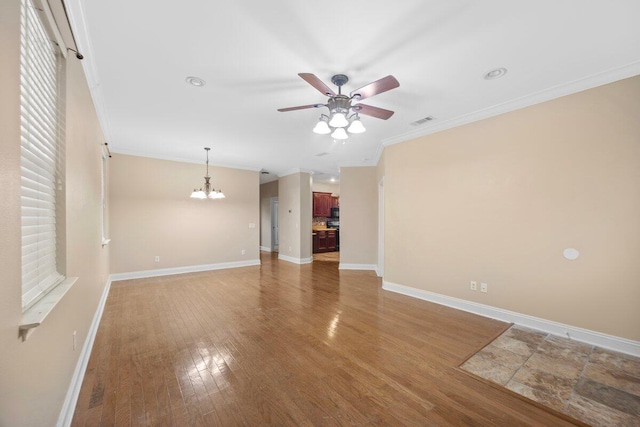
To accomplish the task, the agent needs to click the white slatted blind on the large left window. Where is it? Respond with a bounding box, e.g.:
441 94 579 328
20 0 64 310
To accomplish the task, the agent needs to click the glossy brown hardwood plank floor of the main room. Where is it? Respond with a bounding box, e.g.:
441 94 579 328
73 253 570 426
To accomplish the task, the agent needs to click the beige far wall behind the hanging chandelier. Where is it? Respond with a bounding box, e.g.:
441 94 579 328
109 154 260 274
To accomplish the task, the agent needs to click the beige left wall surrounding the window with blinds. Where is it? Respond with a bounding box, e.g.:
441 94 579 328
0 0 109 426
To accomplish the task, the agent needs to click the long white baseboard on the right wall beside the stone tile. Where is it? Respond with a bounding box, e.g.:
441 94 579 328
382 281 640 357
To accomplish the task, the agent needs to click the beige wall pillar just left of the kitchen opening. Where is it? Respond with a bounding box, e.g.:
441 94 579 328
278 173 312 260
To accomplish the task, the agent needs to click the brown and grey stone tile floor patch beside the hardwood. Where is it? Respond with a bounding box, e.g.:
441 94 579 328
461 325 640 427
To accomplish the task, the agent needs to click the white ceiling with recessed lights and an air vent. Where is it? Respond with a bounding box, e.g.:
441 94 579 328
66 0 640 181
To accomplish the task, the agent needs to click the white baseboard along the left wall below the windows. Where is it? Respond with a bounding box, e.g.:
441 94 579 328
56 277 112 427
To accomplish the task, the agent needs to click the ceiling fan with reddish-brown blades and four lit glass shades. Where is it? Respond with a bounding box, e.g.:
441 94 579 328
278 73 400 139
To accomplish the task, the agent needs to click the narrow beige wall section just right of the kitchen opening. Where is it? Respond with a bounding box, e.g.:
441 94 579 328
340 167 378 265
